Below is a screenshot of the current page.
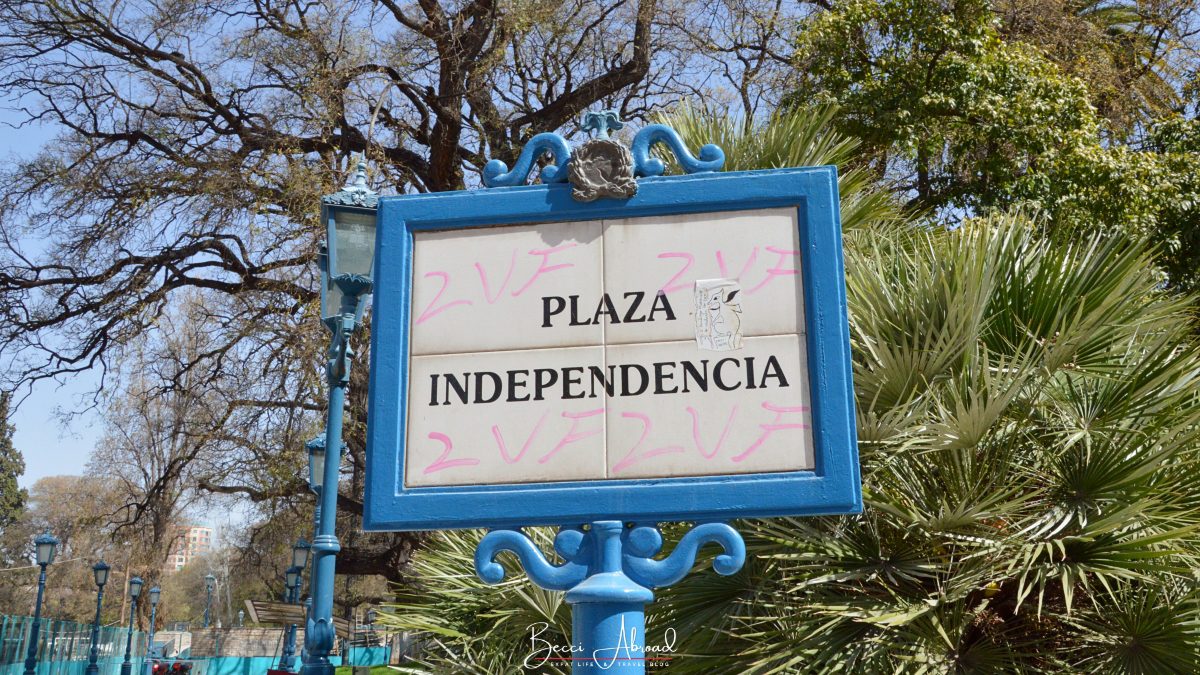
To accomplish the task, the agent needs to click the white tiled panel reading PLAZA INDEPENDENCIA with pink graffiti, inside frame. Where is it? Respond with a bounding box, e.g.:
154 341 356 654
404 208 814 488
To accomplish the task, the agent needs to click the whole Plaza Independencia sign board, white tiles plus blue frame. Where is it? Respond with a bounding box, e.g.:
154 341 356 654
365 167 862 530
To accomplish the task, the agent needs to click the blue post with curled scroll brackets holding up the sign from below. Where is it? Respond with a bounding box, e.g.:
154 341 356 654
475 520 745 675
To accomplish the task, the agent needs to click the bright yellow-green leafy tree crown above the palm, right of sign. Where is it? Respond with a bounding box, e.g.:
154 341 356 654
792 0 1097 209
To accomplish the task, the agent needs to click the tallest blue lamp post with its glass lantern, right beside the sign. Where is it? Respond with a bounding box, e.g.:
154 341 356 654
304 154 379 675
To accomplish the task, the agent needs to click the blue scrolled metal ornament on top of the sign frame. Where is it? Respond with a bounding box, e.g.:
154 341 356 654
484 120 725 187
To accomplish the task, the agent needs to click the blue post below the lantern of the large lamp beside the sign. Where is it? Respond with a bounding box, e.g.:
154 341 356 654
302 275 371 675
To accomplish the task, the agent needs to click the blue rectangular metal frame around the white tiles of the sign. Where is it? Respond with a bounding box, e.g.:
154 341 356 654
364 167 862 531
